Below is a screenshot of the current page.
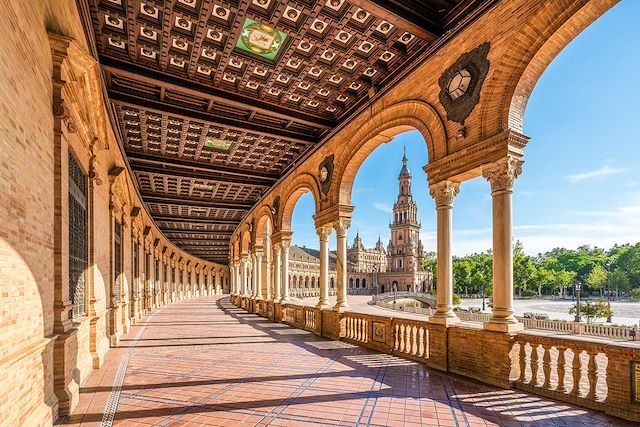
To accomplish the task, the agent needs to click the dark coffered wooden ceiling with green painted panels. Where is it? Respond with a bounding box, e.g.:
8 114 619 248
78 0 495 263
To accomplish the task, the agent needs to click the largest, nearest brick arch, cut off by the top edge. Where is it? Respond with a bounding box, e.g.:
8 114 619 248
480 0 619 139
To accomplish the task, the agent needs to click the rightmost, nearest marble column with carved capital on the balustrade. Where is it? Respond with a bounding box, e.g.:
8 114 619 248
482 156 524 332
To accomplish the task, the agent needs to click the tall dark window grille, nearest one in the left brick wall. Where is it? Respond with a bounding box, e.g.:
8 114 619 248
69 152 89 318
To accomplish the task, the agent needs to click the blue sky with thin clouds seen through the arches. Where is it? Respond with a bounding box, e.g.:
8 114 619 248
292 0 640 255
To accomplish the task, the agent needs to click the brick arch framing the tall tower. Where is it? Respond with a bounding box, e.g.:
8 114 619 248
332 100 448 205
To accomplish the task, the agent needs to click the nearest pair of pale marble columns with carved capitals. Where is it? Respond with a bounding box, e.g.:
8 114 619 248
429 155 523 332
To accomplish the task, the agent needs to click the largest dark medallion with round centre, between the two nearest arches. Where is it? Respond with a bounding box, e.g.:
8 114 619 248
438 43 490 125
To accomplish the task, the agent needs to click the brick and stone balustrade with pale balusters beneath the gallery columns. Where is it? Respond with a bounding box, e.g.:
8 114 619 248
232 296 640 422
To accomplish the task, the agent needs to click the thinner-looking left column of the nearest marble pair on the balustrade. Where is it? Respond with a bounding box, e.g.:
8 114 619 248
429 181 460 325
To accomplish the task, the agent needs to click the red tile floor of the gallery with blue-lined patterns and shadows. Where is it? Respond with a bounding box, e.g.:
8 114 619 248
59 297 630 427
